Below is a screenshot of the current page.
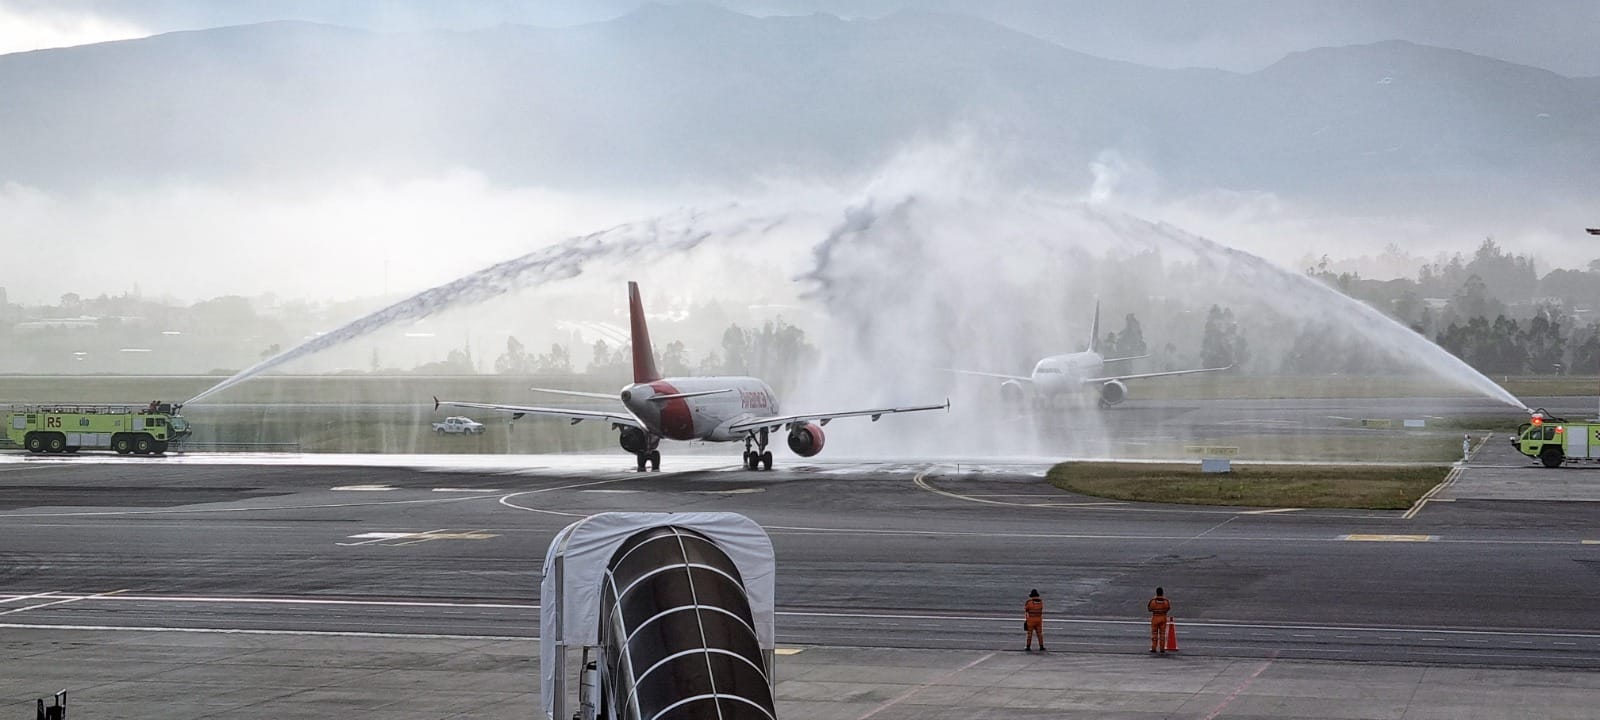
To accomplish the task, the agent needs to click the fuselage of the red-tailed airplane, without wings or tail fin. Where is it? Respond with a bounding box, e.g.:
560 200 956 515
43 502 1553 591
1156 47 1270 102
621 378 778 442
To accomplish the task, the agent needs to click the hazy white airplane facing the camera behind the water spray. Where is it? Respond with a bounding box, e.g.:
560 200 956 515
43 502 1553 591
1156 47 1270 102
946 302 1232 408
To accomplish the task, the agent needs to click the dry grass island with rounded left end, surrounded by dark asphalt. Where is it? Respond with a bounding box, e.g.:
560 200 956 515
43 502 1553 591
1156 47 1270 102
1048 462 1450 510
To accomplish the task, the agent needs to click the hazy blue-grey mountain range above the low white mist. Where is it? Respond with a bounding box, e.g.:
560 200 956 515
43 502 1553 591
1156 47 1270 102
0 5 1600 205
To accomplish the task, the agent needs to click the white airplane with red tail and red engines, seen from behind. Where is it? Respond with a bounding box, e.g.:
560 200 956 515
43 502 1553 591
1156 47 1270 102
434 282 950 472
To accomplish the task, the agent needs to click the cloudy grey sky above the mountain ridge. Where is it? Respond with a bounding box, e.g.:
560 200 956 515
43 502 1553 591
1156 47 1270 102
0 0 1600 75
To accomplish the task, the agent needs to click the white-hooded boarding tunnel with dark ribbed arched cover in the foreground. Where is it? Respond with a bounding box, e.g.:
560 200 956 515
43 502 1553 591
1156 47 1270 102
539 512 776 720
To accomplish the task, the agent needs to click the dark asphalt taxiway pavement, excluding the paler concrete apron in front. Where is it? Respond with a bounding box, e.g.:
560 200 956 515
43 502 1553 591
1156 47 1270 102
0 438 1600 667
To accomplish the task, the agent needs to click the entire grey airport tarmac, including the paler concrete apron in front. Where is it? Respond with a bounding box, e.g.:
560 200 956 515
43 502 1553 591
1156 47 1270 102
0 448 1600 718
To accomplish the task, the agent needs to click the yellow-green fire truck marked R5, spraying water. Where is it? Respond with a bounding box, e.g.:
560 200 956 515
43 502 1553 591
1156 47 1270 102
5 402 189 454
